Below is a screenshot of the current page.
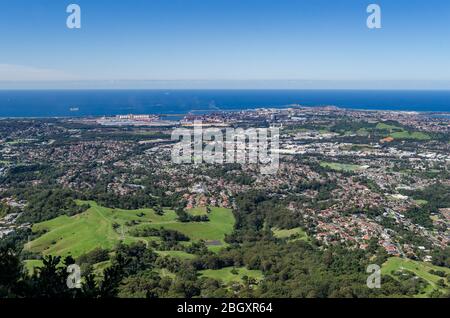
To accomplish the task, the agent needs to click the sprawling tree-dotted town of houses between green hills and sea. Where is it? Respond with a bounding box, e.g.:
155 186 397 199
0 105 450 296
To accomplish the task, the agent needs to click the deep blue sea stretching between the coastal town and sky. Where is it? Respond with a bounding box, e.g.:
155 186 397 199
0 90 450 117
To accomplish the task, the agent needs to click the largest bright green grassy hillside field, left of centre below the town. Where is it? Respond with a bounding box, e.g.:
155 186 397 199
25 201 235 258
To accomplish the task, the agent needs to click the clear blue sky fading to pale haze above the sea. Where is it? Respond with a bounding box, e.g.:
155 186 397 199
0 0 450 88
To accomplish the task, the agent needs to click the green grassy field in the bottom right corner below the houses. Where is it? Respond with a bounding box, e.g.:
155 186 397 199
381 257 450 297
